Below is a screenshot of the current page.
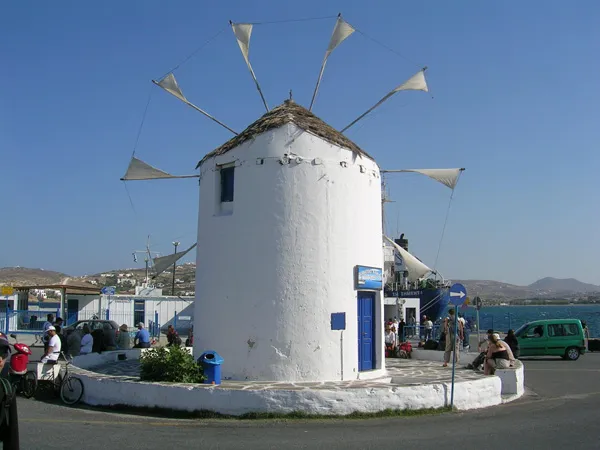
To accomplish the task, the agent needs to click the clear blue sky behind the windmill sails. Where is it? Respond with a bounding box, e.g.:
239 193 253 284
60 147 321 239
0 1 600 284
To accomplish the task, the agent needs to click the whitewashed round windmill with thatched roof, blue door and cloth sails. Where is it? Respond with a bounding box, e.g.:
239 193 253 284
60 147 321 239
122 15 464 381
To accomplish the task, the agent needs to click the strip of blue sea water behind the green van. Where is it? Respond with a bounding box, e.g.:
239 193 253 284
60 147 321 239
458 304 600 337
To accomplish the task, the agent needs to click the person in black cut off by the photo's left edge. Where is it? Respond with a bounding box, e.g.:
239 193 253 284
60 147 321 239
0 333 19 450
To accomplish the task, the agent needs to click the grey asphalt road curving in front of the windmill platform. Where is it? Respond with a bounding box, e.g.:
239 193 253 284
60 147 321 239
12 353 600 450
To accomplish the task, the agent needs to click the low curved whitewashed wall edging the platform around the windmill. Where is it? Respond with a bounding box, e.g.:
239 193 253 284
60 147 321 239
73 350 510 415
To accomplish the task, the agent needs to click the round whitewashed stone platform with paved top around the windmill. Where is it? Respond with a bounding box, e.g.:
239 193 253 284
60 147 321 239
73 350 520 415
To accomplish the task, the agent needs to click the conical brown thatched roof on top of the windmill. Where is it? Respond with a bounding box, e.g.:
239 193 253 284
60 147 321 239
196 100 374 168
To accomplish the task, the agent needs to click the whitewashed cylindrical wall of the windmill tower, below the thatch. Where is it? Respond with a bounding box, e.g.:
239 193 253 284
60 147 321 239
194 124 385 381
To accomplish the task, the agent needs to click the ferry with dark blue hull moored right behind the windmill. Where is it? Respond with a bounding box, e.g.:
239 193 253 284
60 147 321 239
384 234 451 325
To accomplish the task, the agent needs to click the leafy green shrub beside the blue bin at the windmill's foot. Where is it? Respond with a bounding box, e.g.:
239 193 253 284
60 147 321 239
140 346 204 383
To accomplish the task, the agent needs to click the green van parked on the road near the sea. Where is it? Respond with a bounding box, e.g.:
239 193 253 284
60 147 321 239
515 319 585 361
